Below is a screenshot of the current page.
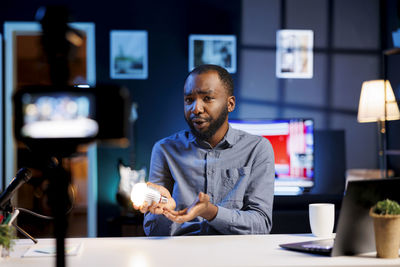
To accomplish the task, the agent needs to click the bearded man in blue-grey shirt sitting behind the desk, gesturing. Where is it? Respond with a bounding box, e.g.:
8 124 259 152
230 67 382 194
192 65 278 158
134 65 275 235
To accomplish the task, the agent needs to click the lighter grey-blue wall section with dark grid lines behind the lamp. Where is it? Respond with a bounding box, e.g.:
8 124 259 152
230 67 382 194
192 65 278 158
238 0 385 172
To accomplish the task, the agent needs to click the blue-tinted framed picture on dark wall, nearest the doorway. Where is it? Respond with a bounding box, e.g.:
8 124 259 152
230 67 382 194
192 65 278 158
110 30 148 79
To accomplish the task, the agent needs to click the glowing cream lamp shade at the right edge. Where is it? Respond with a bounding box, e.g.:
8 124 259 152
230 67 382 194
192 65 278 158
357 80 400 122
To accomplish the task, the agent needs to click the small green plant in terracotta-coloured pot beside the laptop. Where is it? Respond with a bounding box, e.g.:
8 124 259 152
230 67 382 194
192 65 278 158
369 199 400 258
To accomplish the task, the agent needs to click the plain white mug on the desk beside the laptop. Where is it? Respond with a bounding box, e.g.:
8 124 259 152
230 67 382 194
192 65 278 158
308 203 335 238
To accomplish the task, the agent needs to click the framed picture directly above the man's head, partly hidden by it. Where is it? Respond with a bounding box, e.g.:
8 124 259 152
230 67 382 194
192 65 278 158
189 34 236 73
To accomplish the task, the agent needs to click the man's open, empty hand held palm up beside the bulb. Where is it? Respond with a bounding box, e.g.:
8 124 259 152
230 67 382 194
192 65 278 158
163 192 218 223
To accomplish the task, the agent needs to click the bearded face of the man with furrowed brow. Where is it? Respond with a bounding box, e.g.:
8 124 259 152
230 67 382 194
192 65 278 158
184 71 235 141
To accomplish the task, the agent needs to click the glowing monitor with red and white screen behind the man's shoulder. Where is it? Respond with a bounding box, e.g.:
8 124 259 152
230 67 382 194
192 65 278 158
229 119 314 195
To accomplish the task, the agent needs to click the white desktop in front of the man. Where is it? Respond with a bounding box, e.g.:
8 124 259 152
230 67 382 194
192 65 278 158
0 235 400 267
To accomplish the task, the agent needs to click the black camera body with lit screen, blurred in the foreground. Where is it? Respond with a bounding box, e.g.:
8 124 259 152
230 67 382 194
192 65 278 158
14 85 131 150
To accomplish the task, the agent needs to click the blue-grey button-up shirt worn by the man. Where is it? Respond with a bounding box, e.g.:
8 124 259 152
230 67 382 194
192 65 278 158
144 127 275 236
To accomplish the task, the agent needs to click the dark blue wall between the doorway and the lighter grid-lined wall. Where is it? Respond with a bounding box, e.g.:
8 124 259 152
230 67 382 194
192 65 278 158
0 0 240 236
